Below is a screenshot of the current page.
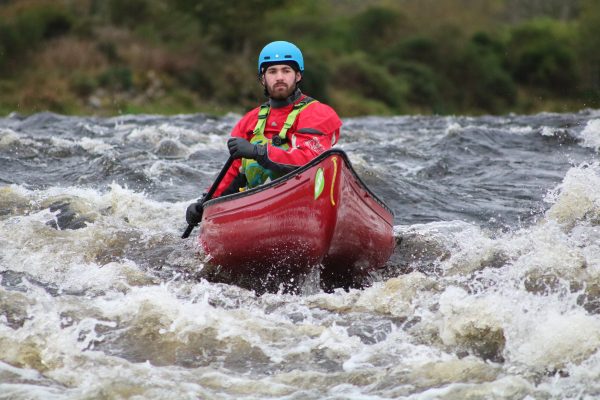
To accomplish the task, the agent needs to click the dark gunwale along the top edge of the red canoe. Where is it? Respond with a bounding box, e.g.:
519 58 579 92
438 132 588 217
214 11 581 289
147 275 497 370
204 149 395 217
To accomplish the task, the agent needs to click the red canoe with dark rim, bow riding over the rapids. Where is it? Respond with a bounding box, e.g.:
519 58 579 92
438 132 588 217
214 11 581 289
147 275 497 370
199 149 395 286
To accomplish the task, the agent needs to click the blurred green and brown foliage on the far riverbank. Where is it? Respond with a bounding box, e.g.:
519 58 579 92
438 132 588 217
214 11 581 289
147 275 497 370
0 0 600 116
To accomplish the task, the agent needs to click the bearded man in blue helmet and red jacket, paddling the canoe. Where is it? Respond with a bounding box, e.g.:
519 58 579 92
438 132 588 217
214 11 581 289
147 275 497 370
186 41 342 225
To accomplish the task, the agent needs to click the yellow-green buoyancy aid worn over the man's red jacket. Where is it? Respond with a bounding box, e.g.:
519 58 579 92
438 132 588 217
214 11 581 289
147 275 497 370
240 96 317 189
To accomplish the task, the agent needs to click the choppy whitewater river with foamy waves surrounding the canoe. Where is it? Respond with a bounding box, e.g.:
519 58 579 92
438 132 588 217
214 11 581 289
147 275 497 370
0 110 600 400
